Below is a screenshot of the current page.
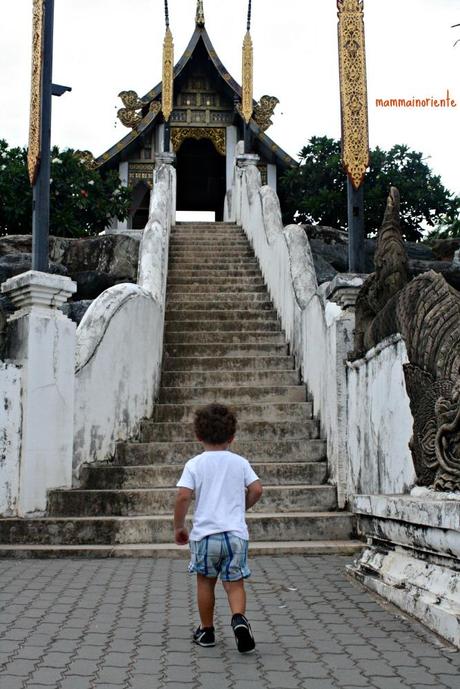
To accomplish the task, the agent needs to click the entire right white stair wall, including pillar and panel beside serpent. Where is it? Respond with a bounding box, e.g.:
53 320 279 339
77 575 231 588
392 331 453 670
226 156 415 507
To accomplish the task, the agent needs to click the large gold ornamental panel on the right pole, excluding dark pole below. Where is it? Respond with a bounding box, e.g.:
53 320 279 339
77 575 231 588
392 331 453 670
337 0 369 189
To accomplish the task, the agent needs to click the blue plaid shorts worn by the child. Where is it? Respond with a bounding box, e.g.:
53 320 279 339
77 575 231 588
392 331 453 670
188 531 251 581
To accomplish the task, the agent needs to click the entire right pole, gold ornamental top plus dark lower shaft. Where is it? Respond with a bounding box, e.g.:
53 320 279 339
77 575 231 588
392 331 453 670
337 0 369 273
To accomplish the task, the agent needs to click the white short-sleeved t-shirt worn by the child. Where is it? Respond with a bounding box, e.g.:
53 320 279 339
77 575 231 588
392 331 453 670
177 450 259 541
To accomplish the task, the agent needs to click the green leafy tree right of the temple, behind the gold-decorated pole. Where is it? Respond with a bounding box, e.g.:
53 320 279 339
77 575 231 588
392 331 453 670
281 136 460 240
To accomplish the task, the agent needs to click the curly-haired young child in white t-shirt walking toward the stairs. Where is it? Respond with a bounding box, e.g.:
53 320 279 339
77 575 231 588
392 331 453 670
174 404 262 653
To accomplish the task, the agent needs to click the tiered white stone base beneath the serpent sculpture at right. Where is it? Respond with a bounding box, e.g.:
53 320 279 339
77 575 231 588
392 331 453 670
348 494 460 648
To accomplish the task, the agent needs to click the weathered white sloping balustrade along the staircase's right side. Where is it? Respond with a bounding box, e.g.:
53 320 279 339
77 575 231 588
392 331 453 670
226 156 354 507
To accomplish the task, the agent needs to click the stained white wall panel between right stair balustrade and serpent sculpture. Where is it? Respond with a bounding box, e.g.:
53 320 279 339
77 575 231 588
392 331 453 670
347 336 416 495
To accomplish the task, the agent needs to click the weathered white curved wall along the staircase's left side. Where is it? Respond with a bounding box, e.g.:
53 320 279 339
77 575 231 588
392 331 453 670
73 165 175 476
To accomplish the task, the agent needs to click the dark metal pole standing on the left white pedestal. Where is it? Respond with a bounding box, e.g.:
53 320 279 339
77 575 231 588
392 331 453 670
32 0 54 273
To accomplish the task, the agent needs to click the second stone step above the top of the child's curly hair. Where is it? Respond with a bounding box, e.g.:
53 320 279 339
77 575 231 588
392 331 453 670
161 370 300 388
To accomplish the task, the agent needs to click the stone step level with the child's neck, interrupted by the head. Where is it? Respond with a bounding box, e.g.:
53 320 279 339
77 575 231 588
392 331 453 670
114 436 327 466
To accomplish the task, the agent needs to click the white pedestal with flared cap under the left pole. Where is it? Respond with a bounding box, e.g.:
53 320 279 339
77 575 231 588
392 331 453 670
2 271 76 516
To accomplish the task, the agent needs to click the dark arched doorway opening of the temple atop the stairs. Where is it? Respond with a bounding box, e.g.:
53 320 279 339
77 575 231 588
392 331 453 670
177 139 226 221
